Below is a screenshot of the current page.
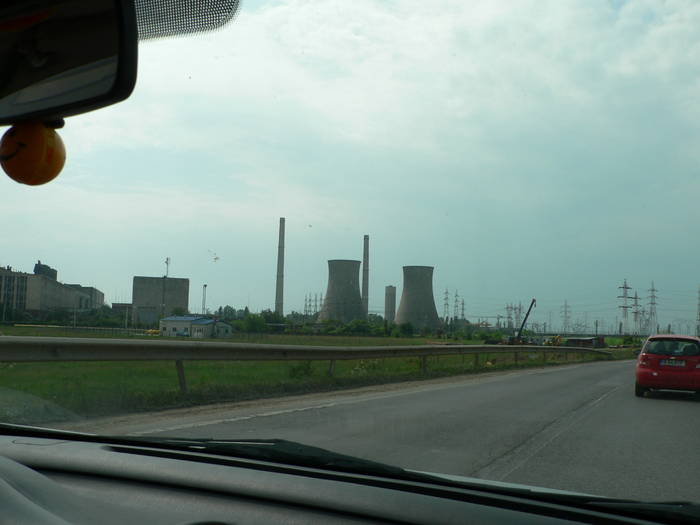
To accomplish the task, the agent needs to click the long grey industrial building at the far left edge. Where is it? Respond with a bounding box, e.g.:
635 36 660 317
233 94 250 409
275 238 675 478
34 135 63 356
0 261 104 317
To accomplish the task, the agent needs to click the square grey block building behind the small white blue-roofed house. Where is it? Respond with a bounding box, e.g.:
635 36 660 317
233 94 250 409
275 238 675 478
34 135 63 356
131 276 190 326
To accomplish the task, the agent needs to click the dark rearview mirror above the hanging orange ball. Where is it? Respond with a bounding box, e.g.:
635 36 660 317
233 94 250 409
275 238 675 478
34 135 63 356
0 0 138 124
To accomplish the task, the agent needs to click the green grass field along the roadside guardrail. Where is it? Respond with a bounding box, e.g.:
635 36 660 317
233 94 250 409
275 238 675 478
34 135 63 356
0 344 632 423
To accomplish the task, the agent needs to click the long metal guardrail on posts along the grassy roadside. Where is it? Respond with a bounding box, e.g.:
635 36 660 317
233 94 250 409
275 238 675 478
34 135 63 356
0 336 612 393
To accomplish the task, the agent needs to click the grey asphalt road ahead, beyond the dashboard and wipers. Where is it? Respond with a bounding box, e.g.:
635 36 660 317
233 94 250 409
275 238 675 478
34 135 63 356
94 361 700 501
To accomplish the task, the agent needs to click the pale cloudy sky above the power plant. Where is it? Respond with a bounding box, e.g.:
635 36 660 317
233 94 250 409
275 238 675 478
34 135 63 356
0 0 700 329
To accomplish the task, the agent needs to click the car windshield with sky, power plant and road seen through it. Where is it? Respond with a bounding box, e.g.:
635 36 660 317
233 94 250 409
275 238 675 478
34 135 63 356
0 0 700 508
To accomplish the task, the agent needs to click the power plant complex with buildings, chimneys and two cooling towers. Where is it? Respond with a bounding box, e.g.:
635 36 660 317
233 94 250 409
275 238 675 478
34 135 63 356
0 217 440 337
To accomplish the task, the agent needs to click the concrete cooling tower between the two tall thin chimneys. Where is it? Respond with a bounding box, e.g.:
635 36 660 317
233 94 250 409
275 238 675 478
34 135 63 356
318 259 365 323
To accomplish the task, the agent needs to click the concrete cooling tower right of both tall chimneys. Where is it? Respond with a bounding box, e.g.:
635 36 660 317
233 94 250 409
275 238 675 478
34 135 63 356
396 266 439 330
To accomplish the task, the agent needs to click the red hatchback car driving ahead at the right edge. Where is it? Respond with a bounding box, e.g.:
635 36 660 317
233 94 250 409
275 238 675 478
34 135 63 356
634 335 700 397
